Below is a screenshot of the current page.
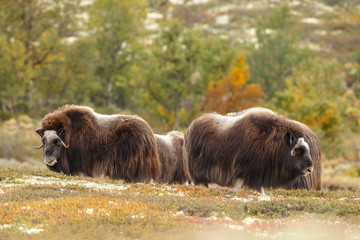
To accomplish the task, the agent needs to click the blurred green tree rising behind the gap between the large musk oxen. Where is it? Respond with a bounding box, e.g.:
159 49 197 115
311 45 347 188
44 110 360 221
142 20 201 128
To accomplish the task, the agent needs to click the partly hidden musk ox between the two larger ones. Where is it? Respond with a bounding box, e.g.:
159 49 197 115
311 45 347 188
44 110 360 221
155 131 190 184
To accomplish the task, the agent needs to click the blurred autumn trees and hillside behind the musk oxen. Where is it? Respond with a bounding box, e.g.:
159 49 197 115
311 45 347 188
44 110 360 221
0 0 360 190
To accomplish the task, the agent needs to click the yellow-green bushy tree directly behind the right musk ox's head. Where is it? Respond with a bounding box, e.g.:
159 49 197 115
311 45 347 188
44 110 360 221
268 58 347 157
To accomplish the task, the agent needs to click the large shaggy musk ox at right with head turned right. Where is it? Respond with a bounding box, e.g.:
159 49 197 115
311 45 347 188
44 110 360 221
185 108 321 191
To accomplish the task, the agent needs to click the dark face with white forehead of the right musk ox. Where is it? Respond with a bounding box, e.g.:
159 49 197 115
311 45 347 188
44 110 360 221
285 134 313 176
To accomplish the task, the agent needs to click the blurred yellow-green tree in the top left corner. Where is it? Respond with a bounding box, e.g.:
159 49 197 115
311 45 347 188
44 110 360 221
0 0 80 113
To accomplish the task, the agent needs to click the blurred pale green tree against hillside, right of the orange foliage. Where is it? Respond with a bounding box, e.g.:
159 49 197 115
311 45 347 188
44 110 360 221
248 5 309 100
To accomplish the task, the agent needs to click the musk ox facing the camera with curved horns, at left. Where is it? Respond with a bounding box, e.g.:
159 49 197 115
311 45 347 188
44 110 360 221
36 105 161 182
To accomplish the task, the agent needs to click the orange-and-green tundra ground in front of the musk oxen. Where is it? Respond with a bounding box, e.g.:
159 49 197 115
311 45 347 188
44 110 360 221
0 169 360 239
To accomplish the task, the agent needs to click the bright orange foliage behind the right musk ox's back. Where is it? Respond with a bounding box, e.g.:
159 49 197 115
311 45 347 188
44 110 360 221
204 56 263 114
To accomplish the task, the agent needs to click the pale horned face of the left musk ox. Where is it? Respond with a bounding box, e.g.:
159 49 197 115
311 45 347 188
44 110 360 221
36 129 69 167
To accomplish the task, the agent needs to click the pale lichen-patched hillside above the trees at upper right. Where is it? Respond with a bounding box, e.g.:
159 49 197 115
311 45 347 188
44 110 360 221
146 0 360 63
